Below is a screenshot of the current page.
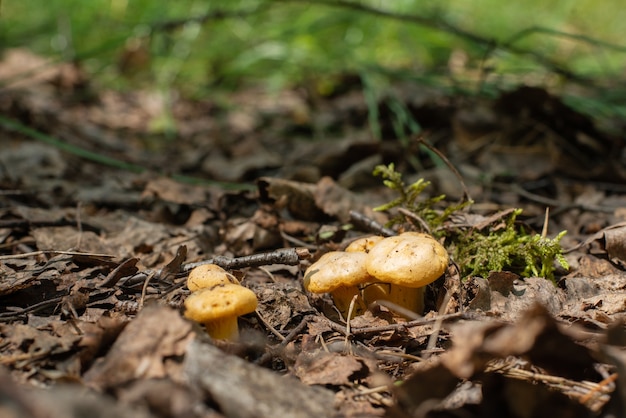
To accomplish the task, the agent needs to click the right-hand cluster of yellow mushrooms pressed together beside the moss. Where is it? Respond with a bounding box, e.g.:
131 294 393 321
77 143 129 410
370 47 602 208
304 232 448 318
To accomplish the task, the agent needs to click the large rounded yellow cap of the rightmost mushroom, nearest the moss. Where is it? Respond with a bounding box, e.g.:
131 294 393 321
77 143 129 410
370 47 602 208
365 232 448 287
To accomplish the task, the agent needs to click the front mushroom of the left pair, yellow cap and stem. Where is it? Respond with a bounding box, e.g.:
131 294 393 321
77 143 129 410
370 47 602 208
185 283 258 340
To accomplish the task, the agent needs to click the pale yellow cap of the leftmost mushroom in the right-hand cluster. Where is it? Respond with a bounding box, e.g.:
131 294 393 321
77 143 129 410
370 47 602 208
304 251 372 293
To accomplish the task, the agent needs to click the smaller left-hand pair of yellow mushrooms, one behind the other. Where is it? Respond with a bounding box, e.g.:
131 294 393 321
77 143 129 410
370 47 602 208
185 264 258 341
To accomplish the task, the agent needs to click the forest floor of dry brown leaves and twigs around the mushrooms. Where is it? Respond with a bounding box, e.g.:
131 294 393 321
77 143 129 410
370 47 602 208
0 50 626 418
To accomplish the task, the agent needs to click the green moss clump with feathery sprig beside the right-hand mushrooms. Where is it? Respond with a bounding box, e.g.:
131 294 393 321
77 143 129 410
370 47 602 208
374 164 568 280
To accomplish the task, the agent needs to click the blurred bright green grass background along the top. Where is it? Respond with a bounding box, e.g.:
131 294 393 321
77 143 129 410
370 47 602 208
0 0 626 115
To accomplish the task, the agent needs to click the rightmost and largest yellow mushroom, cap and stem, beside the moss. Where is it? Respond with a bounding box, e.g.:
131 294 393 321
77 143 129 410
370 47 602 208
362 232 448 314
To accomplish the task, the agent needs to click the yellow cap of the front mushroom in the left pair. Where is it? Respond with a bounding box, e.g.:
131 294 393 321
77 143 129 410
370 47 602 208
185 283 258 323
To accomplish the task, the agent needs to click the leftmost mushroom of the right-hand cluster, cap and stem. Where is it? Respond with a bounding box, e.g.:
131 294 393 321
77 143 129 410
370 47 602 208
304 251 372 318
